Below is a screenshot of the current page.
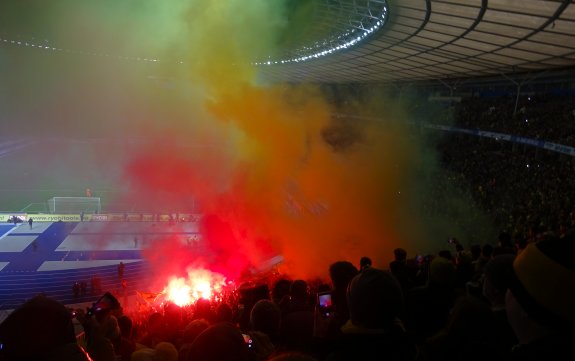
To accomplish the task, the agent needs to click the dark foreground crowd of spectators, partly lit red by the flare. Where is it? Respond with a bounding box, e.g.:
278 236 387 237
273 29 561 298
0 230 575 361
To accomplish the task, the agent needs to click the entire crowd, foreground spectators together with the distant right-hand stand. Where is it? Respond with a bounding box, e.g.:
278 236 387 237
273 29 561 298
0 91 575 361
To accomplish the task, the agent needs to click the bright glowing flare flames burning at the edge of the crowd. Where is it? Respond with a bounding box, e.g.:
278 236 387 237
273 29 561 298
164 269 226 307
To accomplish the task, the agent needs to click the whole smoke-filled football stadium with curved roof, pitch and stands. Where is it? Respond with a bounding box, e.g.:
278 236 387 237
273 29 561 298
0 0 575 361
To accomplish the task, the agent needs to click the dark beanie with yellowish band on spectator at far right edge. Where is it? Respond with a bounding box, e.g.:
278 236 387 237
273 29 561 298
509 233 575 326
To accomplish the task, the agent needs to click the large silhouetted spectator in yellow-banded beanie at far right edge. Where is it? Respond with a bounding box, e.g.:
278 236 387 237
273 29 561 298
505 230 575 360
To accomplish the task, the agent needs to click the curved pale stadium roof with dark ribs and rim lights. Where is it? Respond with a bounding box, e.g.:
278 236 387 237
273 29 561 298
259 0 575 83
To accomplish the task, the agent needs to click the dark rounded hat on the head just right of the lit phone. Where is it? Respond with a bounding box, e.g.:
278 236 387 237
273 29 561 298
347 267 404 329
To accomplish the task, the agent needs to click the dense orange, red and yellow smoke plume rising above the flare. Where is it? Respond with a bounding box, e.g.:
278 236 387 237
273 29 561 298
116 2 424 284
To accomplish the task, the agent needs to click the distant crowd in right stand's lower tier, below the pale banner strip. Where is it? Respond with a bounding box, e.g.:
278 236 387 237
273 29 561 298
441 134 575 238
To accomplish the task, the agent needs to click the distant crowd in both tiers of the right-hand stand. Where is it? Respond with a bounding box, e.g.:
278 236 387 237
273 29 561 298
438 96 575 238
